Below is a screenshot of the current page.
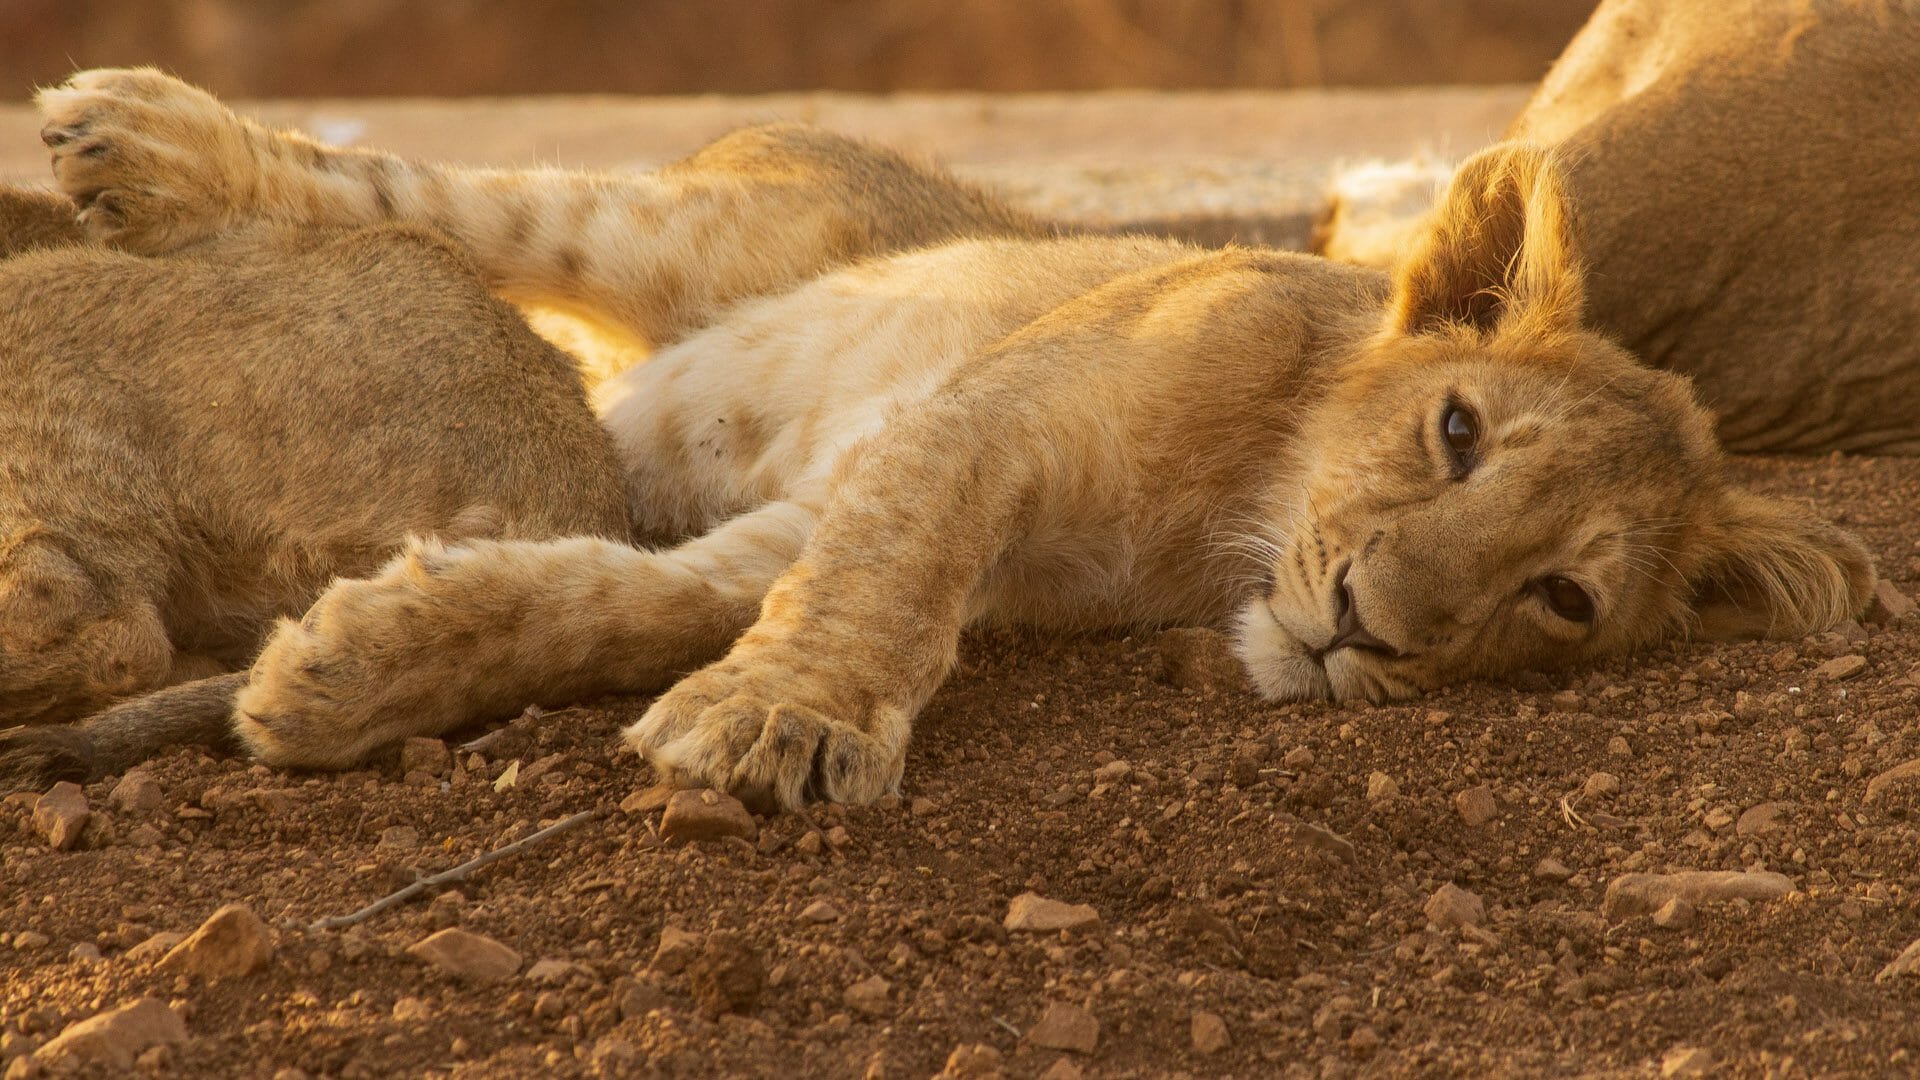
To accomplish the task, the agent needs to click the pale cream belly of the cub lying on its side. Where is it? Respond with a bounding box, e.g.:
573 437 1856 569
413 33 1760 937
595 236 1188 538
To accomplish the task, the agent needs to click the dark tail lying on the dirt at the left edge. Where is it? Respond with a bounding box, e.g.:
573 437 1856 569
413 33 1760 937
0 671 246 794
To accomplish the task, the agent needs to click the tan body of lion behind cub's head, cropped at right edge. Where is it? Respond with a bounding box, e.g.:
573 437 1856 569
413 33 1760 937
1317 0 1920 454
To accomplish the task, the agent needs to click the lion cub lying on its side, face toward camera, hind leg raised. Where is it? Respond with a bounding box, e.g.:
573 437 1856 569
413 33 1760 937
22 71 1872 807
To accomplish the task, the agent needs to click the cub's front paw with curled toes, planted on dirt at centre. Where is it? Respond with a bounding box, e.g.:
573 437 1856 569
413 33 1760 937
626 655 910 811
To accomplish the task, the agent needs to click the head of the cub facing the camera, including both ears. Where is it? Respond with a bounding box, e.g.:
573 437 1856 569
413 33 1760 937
1240 146 1874 700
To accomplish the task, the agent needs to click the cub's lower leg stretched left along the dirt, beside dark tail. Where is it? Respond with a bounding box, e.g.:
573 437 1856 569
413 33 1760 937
234 502 814 767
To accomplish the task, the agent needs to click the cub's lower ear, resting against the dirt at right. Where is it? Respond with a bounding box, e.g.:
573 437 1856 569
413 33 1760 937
1693 492 1874 640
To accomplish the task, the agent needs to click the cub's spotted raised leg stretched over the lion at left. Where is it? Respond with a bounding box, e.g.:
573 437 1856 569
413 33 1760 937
38 69 1041 344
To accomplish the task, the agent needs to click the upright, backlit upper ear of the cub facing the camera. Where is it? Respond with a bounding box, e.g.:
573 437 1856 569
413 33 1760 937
1388 142 1586 334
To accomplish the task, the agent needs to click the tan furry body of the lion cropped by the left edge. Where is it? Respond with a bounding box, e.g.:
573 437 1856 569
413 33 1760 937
0 184 626 726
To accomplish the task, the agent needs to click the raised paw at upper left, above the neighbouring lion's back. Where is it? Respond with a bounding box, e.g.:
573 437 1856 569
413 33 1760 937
36 67 257 254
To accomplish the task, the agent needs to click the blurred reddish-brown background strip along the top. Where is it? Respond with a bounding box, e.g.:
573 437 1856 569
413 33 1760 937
0 0 1594 100
